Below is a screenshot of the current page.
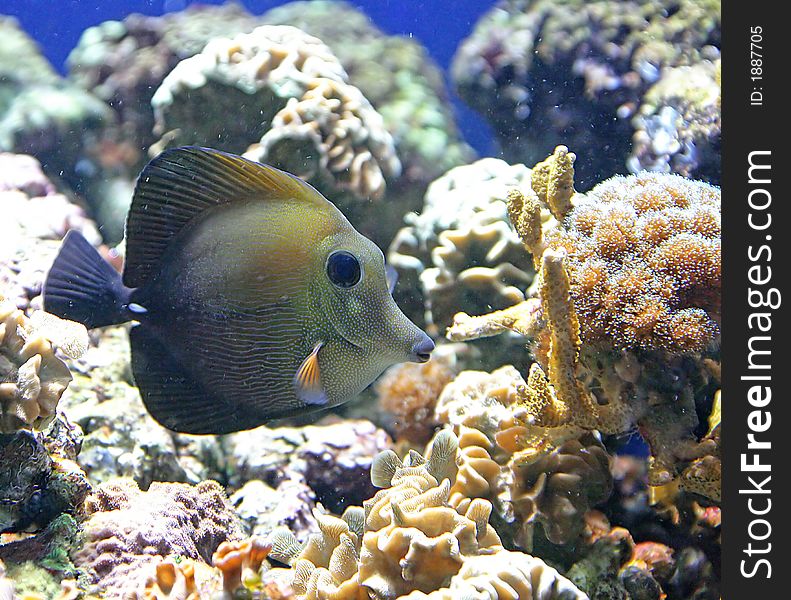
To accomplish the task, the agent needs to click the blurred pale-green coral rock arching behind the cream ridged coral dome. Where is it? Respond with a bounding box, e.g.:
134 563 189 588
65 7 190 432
262 0 473 187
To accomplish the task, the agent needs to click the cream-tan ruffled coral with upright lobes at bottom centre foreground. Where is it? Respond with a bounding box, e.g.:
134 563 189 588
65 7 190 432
272 430 587 600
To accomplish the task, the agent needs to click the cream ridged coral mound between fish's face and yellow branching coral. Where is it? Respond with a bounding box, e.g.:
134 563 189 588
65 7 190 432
387 158 534 335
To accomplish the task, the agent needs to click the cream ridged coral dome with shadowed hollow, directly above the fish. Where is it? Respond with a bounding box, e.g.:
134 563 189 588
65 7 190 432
151 25 401 198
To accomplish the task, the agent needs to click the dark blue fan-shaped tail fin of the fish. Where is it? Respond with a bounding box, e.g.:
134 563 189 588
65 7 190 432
43 230 132 329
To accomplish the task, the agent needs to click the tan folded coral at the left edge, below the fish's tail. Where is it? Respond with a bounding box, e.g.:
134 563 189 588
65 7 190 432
0 296 87 432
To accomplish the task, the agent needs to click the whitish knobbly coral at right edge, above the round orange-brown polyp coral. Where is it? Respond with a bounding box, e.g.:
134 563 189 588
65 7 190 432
627 59 722 184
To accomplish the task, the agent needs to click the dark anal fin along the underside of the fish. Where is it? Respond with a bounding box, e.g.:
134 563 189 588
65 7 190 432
129 325 248 434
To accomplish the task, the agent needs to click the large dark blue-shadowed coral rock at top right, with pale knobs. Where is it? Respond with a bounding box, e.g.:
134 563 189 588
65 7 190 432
452 0 720 189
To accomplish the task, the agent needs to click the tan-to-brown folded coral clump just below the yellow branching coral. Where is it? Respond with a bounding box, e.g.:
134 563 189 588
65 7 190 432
436 365 612 550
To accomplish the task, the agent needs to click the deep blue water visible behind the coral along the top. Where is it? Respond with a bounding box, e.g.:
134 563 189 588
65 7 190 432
6 0 495 156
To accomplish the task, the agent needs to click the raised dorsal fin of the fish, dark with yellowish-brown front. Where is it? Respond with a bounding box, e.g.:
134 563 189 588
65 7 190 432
124 146 329 287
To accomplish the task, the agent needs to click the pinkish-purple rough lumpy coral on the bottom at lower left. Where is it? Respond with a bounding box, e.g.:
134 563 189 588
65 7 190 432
73 479 242 598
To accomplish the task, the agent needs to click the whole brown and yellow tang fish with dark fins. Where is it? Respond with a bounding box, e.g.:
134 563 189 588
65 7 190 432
44 147 434 434
